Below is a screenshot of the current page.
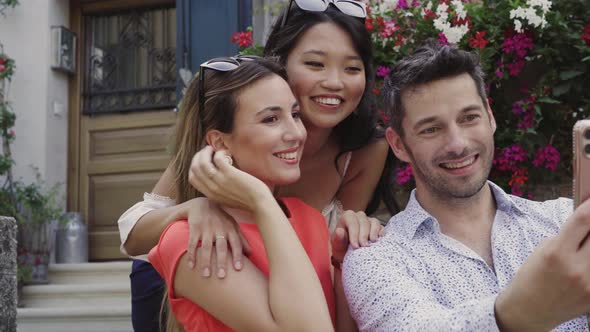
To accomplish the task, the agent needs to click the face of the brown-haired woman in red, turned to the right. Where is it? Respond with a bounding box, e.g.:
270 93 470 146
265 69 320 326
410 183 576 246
225 75 307 186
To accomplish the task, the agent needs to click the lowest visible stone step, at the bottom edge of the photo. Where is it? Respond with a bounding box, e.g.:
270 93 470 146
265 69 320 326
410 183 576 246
17 304 133 332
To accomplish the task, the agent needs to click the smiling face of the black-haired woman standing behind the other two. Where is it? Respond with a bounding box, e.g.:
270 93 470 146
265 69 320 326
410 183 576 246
287 22 365 128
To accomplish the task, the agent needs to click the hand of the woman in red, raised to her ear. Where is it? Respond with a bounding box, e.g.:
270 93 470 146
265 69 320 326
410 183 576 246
189 146 273 212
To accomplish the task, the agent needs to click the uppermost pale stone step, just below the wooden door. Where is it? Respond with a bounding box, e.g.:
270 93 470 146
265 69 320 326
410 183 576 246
49 261 131 284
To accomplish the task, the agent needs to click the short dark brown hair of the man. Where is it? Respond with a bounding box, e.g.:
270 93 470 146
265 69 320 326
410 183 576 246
382 42 487 137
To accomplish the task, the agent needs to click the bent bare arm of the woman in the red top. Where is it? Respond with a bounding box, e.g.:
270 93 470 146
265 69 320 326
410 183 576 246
173 153 333 331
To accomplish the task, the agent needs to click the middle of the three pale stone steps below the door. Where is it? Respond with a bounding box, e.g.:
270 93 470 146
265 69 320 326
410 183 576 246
22 279 131 308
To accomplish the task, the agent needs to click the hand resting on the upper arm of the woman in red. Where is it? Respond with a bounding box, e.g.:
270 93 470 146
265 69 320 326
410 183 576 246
182 197 251 278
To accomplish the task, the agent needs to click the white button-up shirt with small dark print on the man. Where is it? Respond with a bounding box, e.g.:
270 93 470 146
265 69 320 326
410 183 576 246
342 182 588 332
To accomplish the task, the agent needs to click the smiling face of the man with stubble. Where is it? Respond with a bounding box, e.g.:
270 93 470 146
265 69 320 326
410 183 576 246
386 74 496 200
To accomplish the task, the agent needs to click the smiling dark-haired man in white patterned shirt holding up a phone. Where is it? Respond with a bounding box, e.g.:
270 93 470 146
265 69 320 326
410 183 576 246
343 44 590 331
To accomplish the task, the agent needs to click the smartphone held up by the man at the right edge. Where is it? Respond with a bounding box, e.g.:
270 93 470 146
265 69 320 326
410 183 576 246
573 119 590 208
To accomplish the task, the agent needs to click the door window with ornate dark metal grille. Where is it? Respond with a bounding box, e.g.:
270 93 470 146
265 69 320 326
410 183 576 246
83 7 176 114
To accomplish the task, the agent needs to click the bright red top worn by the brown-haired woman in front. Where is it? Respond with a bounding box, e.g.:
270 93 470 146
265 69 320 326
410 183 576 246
149 198 336 332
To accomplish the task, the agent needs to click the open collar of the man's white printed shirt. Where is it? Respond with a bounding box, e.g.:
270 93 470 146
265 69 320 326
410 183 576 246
391 181 524 239
